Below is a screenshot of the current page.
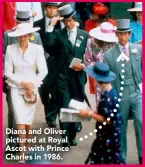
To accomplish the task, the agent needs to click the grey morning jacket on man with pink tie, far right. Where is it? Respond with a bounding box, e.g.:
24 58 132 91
104 43 142 95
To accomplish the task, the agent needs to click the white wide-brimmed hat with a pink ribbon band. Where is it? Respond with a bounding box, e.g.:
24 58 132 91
89 22 118 43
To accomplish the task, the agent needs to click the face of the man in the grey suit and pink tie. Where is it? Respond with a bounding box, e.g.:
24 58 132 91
116 32 130 46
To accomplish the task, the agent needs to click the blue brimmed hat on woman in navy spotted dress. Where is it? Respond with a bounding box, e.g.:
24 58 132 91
85 62 116 83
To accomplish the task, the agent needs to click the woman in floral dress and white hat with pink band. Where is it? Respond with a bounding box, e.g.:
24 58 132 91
84 22 118 107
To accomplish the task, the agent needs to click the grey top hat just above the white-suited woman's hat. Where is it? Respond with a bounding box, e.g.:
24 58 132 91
15 10 31 22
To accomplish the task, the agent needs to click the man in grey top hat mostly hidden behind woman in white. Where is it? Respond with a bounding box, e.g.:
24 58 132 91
3 11 42 153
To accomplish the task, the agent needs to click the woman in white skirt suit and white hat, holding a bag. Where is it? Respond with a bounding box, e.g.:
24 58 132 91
5 23 47 163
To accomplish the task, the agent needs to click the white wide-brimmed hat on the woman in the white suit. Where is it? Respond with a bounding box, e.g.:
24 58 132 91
8 23 40 37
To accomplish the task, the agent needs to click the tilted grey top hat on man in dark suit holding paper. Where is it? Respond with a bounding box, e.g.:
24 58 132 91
58 4 76 20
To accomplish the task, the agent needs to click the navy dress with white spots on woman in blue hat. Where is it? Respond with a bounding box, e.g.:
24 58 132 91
85 88 123 164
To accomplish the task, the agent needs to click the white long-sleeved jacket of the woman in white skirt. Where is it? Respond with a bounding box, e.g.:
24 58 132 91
5 42 48 88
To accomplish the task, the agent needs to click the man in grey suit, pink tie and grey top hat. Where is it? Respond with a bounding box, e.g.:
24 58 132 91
104 19 142 164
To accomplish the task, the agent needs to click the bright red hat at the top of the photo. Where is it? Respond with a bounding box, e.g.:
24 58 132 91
93 3 108 15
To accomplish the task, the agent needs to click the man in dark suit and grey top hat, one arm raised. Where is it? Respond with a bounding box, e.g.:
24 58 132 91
44 4 89 146
